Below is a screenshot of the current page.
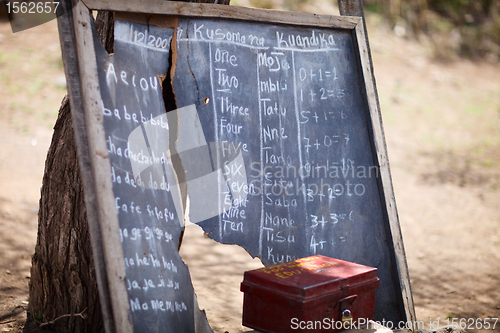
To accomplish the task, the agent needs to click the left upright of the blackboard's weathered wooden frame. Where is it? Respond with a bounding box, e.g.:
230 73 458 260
58 1 133 332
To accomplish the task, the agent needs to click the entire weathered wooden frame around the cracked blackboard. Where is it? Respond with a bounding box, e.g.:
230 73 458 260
59 0 416 332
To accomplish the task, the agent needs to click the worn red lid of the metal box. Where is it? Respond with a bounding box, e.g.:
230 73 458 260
243 255 377 297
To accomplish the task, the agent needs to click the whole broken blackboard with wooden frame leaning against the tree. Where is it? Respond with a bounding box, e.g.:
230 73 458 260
61 1 414 332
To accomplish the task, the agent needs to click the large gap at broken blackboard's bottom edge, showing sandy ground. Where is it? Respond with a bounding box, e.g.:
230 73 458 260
180 224 263 332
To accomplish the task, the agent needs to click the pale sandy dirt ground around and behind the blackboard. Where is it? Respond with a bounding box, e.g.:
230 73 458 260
0 5 500 332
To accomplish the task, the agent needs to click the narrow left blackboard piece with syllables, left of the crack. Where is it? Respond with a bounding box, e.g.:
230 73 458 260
97 20 197 332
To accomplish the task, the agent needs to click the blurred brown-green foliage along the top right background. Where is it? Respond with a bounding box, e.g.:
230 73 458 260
235 0 500 63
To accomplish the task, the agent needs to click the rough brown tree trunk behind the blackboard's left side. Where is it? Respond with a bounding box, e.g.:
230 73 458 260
25 0 229 333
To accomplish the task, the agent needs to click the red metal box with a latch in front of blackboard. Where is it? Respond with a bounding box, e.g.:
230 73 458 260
241 255 379 333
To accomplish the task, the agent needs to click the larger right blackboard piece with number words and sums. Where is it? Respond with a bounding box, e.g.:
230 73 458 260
173 18 400 322
